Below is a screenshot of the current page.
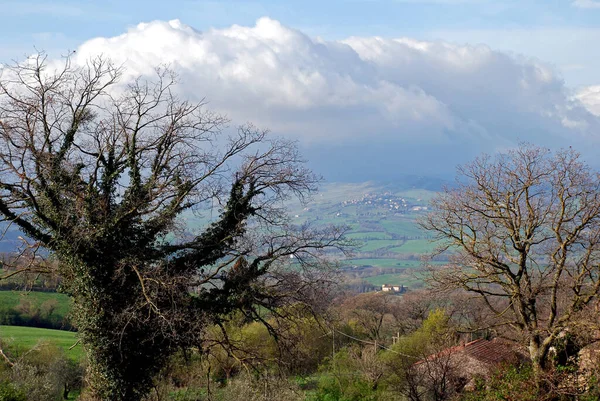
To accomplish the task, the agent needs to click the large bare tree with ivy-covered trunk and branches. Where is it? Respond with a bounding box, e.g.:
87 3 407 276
0 54 342 400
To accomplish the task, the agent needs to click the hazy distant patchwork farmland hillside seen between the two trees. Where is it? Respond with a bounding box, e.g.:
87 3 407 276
284 180 448 287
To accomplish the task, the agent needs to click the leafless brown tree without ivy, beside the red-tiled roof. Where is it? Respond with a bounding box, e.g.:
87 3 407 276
421 144 600 377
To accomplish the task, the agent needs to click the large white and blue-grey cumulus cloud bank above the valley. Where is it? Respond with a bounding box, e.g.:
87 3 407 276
70 18 600 179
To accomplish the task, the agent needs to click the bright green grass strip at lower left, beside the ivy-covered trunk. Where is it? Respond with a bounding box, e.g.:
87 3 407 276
0 326 83 360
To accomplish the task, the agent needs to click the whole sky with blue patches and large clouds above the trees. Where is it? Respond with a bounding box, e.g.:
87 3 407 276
0 0 600 181
